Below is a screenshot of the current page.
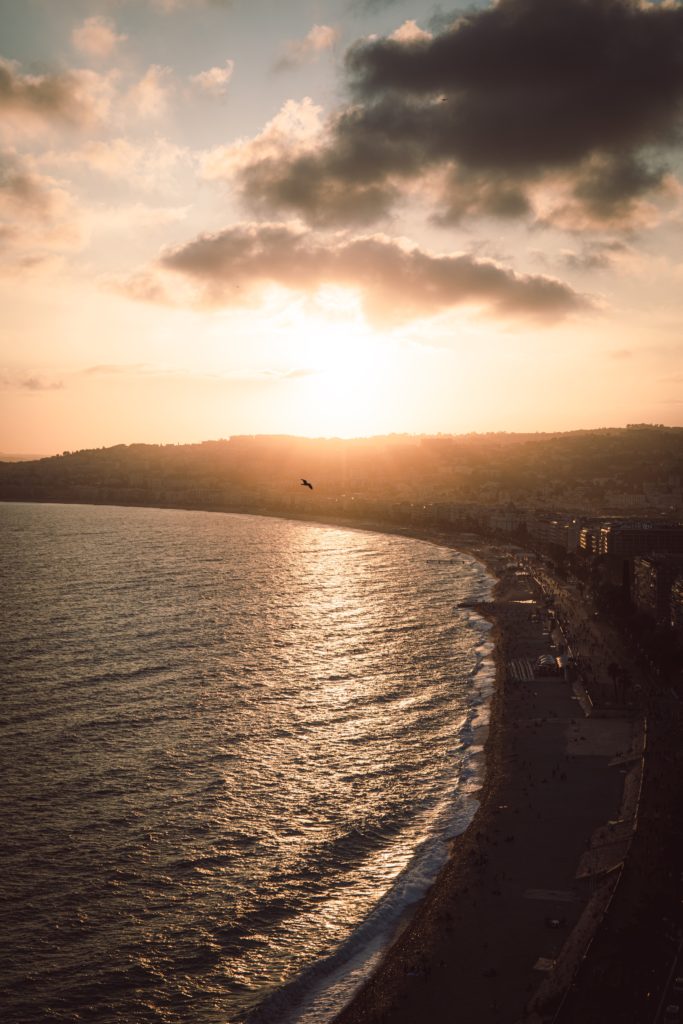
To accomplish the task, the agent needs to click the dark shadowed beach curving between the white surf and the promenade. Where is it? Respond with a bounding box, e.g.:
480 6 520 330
336 534 638 1024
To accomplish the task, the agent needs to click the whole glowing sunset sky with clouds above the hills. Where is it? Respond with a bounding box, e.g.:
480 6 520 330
0 0 683 455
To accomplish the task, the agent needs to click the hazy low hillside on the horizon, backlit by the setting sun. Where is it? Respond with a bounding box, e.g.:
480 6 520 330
0 425 683 511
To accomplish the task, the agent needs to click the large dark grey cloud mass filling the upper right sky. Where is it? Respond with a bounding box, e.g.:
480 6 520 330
236 0 683 224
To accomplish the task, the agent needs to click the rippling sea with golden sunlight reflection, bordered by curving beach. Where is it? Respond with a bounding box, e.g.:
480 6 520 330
0 503 493 1024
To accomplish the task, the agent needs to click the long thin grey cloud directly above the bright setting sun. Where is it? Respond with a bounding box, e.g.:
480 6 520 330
121 224 589 326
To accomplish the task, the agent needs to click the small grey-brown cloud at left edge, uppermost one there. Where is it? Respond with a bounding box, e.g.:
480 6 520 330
0 57 113 130
